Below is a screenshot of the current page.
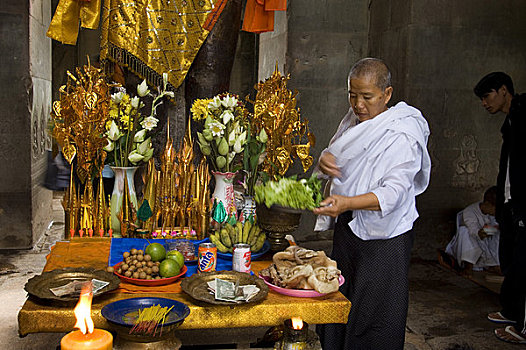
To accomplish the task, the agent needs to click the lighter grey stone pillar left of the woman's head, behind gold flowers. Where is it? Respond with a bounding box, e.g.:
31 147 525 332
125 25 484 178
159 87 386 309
259 0 369 249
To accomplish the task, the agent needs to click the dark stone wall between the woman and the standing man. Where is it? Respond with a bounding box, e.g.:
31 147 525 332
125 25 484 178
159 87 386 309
369 0 526 258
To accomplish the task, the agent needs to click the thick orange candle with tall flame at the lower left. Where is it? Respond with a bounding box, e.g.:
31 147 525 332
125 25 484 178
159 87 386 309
60 283 113 350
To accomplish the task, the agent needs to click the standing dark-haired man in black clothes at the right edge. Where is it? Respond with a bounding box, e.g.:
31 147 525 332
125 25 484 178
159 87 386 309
474 72 526 343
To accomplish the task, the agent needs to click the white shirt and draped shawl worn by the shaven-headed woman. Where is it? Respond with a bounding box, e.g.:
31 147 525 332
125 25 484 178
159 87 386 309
317 102 431 240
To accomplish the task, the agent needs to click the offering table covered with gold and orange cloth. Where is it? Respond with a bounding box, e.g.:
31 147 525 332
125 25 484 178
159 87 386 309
18 238 351 336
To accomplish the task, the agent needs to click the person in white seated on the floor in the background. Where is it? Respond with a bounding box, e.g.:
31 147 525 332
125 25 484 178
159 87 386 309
446 186 500 276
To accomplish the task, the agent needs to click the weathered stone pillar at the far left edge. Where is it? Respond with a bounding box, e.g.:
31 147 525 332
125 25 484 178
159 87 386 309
0 0 51 249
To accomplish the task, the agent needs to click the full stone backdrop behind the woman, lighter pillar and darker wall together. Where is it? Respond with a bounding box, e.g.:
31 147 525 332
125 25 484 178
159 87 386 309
260 0 526 259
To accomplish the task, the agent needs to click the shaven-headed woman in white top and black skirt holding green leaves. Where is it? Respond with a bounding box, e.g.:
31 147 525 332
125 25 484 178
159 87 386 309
314 58 431 350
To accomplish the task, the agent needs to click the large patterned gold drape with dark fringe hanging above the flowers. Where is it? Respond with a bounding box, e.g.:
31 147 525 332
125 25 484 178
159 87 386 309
101 0 227 87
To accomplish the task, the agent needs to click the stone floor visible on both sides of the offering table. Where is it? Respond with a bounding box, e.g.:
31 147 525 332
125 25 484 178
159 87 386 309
0 193 520 350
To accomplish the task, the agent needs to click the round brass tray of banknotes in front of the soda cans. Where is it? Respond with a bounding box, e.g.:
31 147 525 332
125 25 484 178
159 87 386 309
181 271 268 306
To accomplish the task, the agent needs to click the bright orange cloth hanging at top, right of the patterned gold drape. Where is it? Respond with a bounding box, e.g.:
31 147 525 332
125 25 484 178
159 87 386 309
242 0 287 33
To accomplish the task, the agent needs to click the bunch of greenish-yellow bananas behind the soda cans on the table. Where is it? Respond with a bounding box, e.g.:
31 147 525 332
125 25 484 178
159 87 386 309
210 220 266 253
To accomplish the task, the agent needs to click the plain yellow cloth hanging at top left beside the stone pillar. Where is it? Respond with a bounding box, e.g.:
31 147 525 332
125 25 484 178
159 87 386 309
47 0 101 45
